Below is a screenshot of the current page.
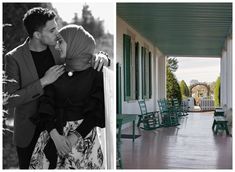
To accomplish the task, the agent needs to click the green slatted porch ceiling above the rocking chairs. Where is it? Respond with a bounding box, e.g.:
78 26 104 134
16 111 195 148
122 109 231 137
117 3 232 57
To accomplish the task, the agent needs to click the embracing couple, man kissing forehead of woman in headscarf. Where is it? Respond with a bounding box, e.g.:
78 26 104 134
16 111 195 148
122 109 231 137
4 8 110 169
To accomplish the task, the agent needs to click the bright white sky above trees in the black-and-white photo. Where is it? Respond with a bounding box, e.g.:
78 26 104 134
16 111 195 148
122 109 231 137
52 2 116 34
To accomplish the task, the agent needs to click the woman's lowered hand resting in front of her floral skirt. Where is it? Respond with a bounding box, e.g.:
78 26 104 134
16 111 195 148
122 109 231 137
50 129 72 156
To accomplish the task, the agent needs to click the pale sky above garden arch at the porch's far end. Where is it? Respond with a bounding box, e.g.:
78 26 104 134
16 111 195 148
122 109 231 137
175 57 220 85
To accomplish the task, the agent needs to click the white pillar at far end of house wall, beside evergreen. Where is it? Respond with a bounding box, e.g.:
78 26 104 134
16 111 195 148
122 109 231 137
157 56 166 99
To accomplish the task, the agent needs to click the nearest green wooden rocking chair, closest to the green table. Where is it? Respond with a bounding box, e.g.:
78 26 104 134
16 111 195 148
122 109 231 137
137 100 160 130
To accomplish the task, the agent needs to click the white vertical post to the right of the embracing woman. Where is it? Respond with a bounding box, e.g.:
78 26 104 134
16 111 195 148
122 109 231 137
103 67 116 169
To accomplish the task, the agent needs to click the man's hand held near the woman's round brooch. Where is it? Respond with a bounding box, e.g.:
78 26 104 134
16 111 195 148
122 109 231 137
40 65 64 87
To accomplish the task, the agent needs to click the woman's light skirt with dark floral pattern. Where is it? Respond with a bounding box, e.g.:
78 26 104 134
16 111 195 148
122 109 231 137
29 120 104 169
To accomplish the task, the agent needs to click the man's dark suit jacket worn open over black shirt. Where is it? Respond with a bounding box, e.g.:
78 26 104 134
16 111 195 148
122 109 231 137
4 39 63 148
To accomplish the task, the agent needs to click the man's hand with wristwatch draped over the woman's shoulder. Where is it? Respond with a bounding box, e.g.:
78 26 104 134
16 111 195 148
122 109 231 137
94 51 109 71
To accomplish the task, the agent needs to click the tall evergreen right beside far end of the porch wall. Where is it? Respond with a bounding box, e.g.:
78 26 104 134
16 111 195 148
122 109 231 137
166 58 182 102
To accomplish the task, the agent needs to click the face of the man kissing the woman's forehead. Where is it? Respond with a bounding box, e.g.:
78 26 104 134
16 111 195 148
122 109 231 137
39 19 58 45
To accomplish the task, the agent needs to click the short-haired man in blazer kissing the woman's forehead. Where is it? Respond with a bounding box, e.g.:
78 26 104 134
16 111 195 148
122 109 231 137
5 8 108 169
